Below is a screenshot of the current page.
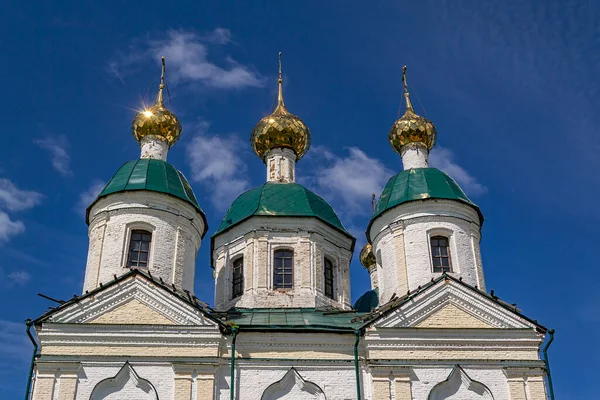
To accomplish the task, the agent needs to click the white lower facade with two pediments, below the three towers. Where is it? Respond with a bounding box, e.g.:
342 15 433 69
33 275 547 400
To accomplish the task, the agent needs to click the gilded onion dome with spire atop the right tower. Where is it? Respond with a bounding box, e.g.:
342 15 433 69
388 66 437 154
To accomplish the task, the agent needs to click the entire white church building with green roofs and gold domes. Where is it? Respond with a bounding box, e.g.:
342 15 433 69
27 55 553 400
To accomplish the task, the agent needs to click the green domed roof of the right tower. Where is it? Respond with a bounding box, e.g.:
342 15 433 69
367 168 483 235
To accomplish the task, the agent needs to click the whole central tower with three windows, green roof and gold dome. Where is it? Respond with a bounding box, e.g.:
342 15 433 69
211 53 354 310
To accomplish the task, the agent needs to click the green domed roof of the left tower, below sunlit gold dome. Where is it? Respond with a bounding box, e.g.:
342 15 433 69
86 158 208 234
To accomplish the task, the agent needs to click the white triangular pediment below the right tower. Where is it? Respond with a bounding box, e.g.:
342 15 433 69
372 280 535 329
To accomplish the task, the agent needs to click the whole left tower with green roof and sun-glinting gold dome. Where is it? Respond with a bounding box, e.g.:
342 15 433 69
83 59 208 292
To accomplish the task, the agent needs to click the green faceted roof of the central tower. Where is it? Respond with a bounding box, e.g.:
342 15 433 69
213 182 351 237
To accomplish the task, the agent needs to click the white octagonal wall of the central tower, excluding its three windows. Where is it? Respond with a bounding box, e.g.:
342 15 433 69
213 216 353 310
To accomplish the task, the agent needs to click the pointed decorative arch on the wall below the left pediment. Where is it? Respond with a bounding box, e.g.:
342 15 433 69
90 361 158 400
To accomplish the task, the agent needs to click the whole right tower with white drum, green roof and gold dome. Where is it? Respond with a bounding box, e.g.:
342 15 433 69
367 67 485 302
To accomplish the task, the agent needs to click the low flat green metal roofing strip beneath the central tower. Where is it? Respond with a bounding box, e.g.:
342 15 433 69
228 308 366 331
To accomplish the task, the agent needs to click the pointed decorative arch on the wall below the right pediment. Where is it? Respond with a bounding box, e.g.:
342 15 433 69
427 365 494 400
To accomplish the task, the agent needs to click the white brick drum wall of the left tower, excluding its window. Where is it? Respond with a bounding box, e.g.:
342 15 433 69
83 191 205 293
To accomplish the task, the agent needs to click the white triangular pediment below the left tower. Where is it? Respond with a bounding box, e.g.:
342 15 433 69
47 275 217 328
